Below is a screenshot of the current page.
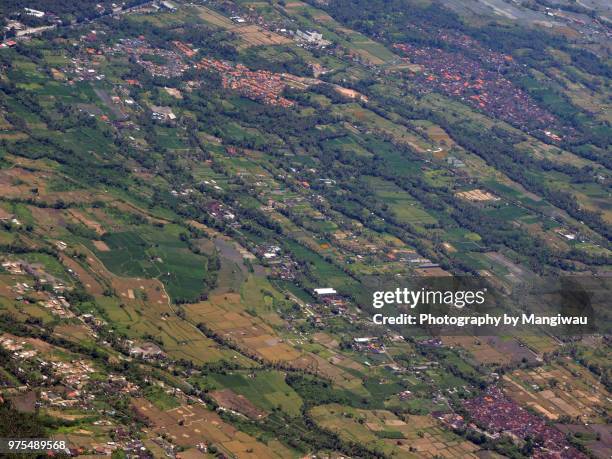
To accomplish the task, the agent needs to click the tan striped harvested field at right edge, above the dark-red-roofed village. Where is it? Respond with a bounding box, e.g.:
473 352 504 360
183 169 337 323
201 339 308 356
503 361 612 423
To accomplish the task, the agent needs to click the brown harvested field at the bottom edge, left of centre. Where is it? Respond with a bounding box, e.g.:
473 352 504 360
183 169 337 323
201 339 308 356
132 398 288 459
